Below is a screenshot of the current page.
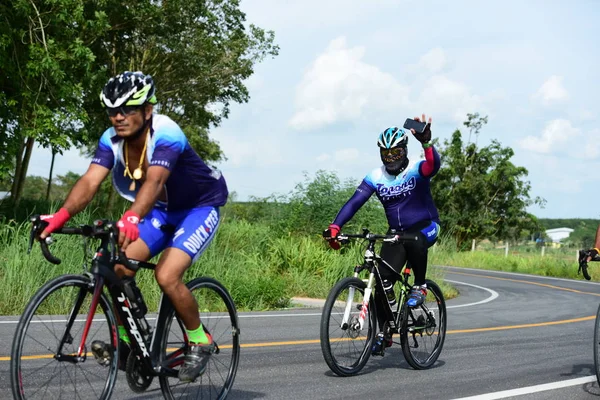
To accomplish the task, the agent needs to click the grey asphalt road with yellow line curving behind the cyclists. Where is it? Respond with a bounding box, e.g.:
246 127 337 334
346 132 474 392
0 268 600 400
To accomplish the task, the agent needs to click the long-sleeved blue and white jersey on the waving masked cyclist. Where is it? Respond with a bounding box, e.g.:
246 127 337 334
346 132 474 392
333 149 440 231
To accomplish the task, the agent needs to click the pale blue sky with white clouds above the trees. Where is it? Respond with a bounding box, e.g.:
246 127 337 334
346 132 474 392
30 0 600 218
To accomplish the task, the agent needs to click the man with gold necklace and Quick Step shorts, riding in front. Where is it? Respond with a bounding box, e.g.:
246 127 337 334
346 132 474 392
41 71 228 382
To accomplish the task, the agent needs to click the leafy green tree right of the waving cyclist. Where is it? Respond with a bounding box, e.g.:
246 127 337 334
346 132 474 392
432 114 545 249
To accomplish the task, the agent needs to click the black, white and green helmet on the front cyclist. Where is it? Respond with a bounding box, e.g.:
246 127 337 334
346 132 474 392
100 71 157 108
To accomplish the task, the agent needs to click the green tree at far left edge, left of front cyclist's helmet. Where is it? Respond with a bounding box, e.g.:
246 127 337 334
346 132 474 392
0 0 105 204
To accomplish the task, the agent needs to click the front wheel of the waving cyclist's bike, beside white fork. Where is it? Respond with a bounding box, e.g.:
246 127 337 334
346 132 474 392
320 277 377 376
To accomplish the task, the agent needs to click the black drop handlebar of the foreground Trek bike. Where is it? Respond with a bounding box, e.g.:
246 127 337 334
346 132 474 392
27 215 140 271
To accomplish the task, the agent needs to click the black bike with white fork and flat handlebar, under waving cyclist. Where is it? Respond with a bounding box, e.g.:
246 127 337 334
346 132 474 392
321 229 446 376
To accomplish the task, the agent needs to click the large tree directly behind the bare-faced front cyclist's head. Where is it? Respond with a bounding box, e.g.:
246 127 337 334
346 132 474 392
77 0 279 161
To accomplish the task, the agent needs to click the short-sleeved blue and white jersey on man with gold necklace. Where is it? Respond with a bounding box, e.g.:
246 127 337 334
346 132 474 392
92 114 228 210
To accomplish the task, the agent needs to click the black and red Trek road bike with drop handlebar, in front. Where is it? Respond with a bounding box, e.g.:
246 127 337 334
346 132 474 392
10 216 240 400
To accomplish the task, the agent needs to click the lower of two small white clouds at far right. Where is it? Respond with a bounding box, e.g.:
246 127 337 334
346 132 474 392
519 119 580 154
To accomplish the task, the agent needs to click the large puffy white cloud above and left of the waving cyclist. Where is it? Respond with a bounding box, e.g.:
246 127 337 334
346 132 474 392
289 37 408 129
